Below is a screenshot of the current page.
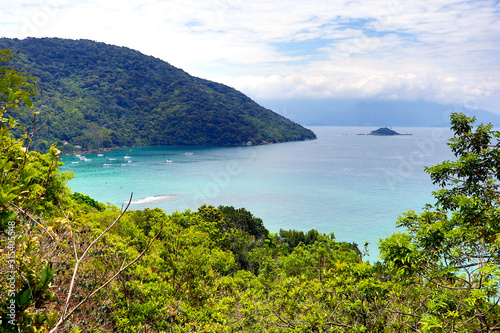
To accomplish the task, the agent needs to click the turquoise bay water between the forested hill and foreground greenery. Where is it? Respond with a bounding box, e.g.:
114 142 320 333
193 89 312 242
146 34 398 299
61 127 453 258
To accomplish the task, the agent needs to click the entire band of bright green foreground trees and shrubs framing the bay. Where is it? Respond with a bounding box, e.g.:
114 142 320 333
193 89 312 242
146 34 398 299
0 47 500 333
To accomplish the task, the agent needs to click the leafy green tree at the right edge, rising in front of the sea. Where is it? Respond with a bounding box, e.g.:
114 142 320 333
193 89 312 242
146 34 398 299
380 114 500 332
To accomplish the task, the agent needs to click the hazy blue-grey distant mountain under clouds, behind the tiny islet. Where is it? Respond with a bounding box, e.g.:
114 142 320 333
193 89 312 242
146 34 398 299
260 99 500 127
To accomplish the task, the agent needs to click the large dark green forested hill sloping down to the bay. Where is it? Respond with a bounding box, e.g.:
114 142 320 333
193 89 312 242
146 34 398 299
0 38 315 150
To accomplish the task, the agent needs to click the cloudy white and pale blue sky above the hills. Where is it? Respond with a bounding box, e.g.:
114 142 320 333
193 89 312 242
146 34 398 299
0 0 500 113
